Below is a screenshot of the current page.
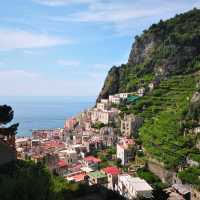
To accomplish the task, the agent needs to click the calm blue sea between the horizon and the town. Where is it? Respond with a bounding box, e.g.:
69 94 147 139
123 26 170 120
0 97 95 136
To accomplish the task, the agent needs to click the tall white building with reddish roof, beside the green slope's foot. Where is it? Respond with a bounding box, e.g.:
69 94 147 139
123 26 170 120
117 139 135 165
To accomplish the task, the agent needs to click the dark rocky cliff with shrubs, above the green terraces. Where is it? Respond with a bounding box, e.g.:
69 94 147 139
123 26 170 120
98 9 200 100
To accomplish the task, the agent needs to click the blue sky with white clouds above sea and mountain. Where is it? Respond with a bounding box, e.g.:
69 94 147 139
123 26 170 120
0 0 200 96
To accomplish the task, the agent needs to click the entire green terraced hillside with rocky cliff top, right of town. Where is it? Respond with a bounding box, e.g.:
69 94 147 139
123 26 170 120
97 9 200 187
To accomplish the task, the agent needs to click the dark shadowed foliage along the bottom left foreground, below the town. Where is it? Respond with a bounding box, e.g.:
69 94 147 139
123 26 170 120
0 160 123 200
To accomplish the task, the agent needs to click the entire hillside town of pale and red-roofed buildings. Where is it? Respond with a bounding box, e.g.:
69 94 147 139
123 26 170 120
13 93 158 199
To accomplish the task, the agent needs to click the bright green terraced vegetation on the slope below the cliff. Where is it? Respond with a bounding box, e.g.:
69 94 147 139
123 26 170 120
138 75 198 169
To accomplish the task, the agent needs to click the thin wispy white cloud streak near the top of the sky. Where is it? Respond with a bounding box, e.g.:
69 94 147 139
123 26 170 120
53 3 163 24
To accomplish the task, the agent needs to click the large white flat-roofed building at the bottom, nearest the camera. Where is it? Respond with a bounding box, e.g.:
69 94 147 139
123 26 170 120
117 174 153 200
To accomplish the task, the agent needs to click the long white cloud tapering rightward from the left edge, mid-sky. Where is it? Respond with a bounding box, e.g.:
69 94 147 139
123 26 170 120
0 29 72 50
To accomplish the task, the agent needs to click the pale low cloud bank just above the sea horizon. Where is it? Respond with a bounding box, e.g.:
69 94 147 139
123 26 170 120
0 69 100 96
